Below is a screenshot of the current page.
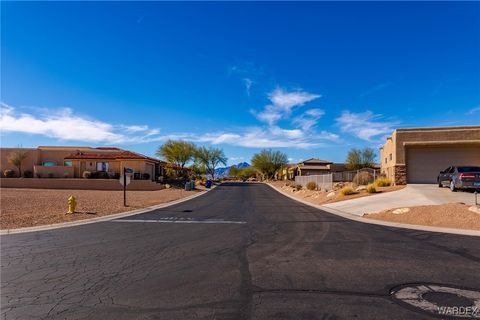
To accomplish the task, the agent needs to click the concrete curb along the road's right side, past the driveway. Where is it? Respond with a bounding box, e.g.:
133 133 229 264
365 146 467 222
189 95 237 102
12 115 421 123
266 183 480 237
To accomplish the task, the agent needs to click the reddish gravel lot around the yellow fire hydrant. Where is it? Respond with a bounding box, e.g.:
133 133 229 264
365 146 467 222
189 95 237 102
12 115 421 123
0 188 201 229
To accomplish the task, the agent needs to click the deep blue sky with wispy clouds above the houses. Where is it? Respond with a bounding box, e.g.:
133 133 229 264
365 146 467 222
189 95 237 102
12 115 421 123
0 2 480 163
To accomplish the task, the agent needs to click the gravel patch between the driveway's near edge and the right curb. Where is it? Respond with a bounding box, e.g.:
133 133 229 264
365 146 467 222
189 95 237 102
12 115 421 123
364 203 480 230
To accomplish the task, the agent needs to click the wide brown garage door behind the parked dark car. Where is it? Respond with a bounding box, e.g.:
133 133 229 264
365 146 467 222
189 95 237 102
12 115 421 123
407 146 480 183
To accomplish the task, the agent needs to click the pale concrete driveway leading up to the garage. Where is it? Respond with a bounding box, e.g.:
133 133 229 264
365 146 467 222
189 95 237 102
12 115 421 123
324 184 480 216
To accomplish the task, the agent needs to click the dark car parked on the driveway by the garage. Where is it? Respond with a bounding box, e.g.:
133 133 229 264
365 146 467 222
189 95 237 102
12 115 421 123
437 166 480 191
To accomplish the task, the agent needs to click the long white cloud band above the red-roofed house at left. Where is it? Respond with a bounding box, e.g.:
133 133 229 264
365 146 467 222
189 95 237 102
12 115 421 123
0 103 160 144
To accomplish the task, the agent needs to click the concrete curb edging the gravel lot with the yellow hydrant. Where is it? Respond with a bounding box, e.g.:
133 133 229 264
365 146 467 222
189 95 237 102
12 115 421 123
0 186 216 236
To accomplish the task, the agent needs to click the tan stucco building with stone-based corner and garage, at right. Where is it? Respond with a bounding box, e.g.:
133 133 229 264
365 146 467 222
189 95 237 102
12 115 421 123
380 126 480 184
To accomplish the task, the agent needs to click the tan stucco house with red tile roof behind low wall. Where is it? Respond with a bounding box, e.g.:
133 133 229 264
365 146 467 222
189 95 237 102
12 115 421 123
0 146 165 180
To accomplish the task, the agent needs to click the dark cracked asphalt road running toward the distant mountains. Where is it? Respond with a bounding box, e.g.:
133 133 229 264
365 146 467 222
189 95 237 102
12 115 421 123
0 184 480 320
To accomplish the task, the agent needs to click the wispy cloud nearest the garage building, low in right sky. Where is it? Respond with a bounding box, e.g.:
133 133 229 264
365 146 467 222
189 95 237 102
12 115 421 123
336 111 398 141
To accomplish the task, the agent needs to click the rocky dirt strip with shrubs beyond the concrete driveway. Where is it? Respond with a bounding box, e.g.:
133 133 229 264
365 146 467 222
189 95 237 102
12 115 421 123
268 181 405 205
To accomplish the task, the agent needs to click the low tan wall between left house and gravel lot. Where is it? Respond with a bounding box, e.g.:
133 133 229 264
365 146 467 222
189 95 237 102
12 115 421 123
0 178 165 191
